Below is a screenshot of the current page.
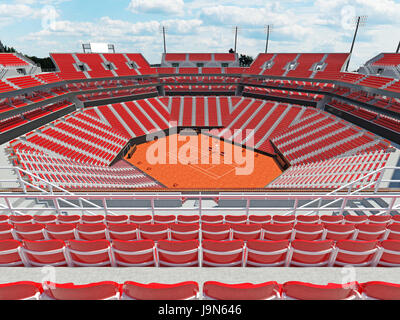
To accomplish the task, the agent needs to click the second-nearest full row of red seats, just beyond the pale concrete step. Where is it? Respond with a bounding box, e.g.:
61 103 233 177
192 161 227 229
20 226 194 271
0 240 400 267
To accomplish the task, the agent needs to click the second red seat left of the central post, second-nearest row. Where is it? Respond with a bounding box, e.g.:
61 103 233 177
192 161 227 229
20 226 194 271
111 240 157 267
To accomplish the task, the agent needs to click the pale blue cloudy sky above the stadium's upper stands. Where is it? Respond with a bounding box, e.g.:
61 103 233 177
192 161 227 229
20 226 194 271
0 0 400 69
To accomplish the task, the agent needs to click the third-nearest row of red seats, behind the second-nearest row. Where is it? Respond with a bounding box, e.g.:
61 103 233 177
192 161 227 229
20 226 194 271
0 223 400 241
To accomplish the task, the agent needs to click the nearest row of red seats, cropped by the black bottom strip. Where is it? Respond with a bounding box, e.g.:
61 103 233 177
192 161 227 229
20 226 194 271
0 281 400 300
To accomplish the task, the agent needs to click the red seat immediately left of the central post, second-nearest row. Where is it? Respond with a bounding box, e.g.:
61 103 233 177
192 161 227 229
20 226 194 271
156 240 201 267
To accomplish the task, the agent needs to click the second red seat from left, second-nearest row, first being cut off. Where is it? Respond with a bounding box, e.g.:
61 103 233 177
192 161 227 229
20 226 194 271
22 240 68 267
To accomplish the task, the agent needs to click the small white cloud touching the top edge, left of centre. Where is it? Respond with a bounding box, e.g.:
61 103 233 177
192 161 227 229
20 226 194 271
128 0 184 15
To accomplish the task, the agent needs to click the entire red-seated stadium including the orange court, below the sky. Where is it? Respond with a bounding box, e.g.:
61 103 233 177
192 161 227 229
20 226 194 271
0 12 400 300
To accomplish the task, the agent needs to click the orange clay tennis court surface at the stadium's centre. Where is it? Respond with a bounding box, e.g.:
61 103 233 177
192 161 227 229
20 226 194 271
125 134 282 189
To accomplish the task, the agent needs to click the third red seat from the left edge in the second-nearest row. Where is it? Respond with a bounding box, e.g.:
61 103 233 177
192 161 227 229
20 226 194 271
67 240 111 267
